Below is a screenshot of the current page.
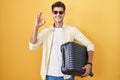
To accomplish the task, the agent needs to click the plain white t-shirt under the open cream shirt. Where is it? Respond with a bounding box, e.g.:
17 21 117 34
48 28 63 76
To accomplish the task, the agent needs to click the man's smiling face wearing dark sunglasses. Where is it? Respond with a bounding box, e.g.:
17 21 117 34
52 7 65 23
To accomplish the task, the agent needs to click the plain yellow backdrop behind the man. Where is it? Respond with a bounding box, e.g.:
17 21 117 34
0 0 120 80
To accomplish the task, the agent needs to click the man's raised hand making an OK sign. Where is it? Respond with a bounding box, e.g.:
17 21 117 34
34 12 45 29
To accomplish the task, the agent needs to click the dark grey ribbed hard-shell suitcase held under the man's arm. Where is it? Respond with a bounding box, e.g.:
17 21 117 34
61 42 93 76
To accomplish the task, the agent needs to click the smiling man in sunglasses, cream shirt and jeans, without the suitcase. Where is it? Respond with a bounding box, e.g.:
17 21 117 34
29 1 94 80
